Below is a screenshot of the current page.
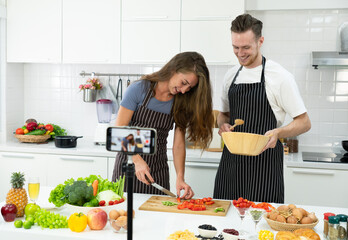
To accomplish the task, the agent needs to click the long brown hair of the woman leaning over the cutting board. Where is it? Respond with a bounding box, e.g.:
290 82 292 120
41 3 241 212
142 52 214 149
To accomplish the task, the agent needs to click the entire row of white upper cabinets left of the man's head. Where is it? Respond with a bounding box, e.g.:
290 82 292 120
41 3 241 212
7 0 244 64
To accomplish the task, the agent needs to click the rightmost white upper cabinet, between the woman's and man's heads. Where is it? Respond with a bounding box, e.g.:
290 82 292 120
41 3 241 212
181 0 244 65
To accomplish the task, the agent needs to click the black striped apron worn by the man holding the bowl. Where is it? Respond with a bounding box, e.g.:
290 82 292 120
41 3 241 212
214 57 284 203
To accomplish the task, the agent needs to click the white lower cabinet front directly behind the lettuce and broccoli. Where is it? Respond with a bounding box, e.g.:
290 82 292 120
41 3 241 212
47 155 108 187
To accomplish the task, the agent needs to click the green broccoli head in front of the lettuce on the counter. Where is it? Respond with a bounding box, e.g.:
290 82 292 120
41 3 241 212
64 181 94 206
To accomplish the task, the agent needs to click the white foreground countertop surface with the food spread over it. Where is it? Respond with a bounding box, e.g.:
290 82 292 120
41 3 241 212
0 187 348 240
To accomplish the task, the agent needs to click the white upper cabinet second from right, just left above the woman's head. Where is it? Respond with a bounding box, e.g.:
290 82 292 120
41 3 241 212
121 0 180 64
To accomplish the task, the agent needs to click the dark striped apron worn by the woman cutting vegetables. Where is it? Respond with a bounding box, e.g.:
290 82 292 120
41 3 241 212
112 85 174 194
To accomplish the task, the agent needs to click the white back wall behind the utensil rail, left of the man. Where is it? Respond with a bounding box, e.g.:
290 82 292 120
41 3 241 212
17 64 228 137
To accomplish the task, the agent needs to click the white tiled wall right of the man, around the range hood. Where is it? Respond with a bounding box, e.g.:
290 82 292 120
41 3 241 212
249 10 348 146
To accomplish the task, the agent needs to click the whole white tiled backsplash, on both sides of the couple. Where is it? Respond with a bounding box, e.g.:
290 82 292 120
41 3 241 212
7 10 348 147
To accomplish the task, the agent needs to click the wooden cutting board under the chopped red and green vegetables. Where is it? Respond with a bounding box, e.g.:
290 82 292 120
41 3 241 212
139 196 231 216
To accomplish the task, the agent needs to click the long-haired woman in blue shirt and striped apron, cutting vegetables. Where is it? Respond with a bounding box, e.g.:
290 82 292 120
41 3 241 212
113 52 213 198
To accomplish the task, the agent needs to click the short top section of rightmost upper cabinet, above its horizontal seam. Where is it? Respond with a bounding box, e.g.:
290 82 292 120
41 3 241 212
181 0 244 20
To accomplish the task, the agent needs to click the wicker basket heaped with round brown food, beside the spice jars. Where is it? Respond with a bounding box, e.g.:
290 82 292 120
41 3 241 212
263 204 319 231
